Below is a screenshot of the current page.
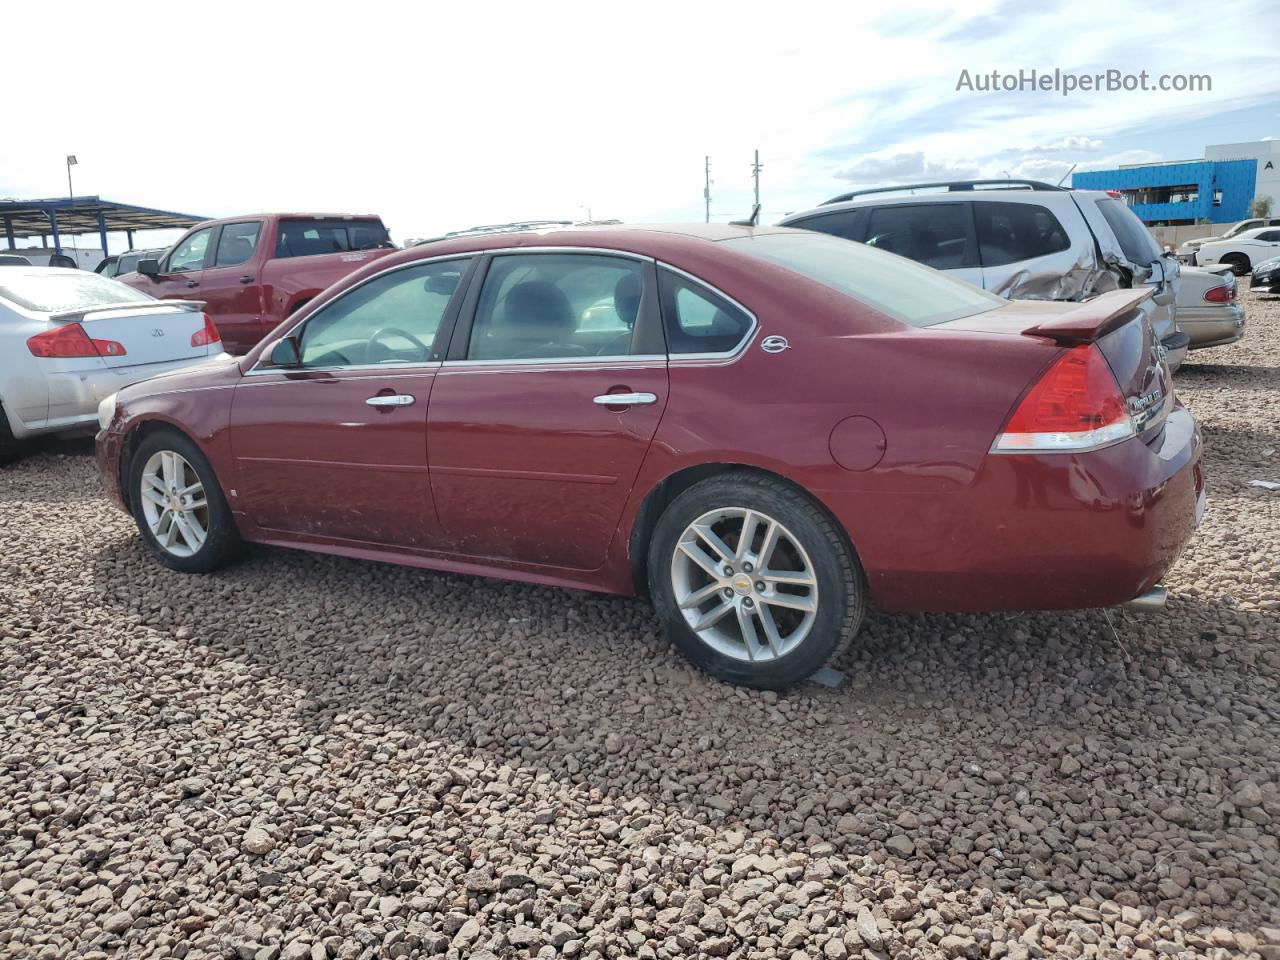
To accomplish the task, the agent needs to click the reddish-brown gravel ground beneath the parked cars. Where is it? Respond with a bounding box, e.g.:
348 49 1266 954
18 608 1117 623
0 281 1280 960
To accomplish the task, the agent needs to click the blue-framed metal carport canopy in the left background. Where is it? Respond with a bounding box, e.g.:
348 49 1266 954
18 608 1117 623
0 197 210 256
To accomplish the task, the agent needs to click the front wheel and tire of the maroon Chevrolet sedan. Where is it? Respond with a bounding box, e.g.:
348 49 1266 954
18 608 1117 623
127 429 242 573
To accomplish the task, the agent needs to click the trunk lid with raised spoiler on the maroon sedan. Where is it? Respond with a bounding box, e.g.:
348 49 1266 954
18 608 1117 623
928 287 1174 439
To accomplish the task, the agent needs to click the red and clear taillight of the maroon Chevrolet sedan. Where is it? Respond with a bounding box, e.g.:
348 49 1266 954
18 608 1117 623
991 343 1137 453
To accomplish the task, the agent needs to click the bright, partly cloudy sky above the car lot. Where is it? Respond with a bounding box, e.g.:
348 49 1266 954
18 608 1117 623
0 0 1280 253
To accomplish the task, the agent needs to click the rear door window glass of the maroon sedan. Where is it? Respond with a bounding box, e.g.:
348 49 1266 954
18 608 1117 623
467 253 644 360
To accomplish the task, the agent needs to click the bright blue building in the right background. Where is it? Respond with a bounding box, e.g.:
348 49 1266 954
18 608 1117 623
1071 160 1258 227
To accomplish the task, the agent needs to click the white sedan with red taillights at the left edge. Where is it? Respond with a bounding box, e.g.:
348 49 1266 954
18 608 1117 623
0 266 227 462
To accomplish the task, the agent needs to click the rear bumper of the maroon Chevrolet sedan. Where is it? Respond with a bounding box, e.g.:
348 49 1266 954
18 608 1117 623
841 406 1204 612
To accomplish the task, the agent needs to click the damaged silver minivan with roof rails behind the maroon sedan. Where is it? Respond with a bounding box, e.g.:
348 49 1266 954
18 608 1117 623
780 180 1188 370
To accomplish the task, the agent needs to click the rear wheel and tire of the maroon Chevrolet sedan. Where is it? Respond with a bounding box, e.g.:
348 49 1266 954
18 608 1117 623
648 472 867 690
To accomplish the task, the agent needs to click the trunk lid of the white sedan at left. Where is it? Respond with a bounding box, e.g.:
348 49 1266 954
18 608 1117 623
50 300 223 367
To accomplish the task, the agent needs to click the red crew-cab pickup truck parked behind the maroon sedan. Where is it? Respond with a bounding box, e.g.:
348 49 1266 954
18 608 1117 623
126 214 394 353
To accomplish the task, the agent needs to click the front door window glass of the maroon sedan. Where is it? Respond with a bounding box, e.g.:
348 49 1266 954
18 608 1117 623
301 260 468 367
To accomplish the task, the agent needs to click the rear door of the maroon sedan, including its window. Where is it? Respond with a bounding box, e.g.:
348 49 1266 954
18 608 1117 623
428 251 667 570
